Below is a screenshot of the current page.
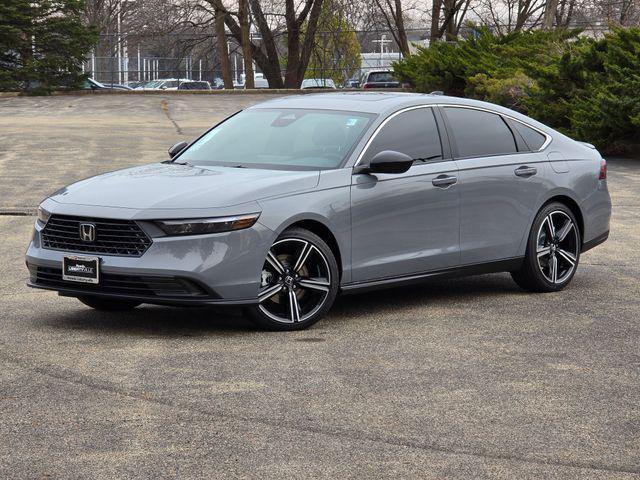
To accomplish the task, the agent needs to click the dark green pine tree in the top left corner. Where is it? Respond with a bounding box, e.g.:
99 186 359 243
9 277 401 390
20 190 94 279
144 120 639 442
0 0 97 92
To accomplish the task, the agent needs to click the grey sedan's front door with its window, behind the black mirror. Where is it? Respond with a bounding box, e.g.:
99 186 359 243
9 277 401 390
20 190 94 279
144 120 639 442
351 107 459 282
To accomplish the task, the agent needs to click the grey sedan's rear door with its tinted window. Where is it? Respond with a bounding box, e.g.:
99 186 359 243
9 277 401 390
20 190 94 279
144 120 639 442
442 106 547 265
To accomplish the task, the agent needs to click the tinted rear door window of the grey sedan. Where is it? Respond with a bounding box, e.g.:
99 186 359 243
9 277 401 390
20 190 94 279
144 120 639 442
445 107 518 157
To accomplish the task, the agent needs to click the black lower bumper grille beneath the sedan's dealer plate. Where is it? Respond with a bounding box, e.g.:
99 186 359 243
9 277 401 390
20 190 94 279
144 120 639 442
29 265 210 299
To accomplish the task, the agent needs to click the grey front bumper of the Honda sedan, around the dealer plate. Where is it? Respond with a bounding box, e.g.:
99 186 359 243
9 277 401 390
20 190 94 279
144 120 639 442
26 217 274 305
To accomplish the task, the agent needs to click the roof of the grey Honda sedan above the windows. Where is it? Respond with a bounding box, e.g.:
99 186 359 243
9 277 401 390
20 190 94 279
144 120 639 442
250 92 550 132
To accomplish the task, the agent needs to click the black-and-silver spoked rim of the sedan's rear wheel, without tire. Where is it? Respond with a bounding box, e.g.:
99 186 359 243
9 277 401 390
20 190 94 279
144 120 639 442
537 210 579 284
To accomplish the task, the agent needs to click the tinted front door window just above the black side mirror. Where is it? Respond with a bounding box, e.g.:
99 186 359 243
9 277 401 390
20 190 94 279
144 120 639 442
363 108 442 164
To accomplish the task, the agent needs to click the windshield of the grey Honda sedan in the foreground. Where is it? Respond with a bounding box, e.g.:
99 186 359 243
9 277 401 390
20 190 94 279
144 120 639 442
177 109 374 170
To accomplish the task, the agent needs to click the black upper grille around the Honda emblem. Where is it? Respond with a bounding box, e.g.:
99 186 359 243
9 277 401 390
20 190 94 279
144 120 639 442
42 215 151 257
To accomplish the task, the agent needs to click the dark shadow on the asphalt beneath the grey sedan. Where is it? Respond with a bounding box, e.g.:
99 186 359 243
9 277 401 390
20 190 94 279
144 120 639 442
35 274 526 337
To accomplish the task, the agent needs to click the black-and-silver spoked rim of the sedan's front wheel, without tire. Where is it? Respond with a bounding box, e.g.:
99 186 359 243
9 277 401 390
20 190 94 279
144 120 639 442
258 238 331 323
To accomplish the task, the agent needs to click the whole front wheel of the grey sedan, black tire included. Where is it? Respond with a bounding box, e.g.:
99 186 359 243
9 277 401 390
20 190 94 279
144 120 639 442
246 228 340 330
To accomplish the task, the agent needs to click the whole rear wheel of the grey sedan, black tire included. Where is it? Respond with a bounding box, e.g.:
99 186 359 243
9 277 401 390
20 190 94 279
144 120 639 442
511 202 582 292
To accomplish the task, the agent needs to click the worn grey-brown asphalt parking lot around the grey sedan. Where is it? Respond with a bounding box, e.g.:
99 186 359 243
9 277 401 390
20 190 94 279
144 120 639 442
0 95 640 479
